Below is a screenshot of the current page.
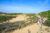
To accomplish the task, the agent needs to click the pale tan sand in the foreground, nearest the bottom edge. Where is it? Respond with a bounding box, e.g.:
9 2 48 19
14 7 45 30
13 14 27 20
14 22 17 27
13 24 39 33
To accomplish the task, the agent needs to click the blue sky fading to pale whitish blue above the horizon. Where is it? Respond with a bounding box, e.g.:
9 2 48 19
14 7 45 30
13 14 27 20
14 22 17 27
0 0 50 13
